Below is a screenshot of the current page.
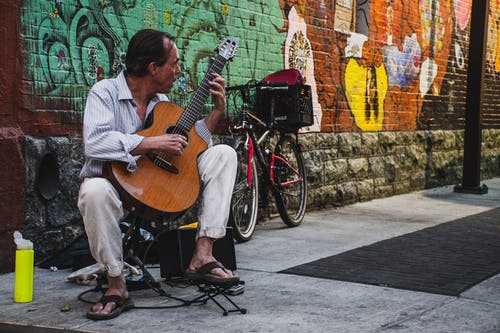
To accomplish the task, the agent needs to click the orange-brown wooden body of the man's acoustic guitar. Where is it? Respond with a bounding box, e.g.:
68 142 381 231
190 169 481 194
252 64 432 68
107 102 207 218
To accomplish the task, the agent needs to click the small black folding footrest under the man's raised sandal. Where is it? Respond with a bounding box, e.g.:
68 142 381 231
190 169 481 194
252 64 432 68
189 280 247 316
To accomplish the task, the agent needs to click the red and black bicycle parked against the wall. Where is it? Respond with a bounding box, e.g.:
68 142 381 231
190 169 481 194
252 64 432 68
226 77 312 242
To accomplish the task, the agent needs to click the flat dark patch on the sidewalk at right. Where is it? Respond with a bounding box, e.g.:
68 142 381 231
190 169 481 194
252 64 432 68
280 208 500 296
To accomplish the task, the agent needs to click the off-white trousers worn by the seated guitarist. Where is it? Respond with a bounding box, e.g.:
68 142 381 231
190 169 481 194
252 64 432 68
78 145 237 277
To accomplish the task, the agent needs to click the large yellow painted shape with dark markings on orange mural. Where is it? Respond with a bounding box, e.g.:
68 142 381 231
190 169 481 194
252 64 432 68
345 59 388 131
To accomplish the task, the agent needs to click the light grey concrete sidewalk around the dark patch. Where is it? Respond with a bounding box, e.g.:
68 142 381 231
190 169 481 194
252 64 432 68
0 178 500 333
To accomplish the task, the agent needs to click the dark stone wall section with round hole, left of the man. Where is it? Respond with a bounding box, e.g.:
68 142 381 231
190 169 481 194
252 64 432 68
23 136 84 262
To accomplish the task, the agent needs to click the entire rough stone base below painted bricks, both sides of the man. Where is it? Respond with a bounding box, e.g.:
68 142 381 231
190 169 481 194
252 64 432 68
24 130 500 260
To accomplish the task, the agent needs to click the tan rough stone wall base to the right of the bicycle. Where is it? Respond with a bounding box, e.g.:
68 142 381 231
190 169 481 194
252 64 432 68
300 130 500 209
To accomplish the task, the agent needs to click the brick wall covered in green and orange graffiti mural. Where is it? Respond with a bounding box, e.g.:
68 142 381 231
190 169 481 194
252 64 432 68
20 0 500 132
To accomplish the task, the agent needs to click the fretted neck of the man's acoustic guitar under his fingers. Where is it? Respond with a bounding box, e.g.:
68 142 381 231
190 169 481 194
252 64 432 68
177 55 227 131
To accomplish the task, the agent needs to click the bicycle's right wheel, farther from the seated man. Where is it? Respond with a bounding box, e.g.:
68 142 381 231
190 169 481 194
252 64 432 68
273 135 307 227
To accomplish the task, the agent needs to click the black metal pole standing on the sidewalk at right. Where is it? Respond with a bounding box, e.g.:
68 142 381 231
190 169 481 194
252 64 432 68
454 0 488 194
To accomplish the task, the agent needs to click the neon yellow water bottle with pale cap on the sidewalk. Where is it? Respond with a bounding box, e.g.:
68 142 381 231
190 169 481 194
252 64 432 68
14 231 35 303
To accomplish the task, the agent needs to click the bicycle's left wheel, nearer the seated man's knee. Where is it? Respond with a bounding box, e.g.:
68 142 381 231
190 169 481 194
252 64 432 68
230 137 259 242
